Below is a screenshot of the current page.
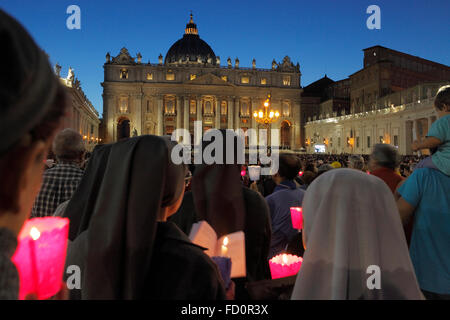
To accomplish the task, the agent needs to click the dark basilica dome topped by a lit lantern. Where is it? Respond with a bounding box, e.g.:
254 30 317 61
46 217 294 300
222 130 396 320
164 14 217 65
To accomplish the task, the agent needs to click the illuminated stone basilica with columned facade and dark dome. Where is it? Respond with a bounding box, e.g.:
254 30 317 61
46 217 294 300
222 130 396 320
102 15 302 150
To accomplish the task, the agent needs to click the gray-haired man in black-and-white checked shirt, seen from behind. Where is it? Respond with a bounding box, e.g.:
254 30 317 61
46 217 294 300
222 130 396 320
31 129 85 217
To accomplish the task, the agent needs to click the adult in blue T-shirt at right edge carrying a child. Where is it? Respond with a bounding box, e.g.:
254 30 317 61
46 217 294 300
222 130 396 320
397 168 450 299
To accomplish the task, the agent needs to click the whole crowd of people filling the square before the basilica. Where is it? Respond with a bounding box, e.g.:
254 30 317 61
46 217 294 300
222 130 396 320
0 10 450 300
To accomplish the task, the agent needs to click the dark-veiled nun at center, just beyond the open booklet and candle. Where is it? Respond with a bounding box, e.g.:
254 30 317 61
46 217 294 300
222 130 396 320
169 130 272 300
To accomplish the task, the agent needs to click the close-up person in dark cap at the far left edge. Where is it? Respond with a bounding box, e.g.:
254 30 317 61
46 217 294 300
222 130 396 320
0 9 68 299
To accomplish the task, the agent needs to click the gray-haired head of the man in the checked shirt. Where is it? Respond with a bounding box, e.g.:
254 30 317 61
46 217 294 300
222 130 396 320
53 129 85 162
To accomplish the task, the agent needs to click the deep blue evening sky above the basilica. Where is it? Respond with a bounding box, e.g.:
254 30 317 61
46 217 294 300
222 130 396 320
0 0 450 113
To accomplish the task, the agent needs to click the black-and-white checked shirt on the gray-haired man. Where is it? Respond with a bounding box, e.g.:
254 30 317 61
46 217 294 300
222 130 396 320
31 162 83 217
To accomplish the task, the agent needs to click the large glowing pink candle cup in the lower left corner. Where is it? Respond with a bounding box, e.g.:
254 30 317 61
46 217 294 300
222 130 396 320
12 217 69 300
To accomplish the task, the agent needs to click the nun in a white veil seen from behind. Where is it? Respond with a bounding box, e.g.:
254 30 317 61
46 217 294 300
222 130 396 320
292 169 423 300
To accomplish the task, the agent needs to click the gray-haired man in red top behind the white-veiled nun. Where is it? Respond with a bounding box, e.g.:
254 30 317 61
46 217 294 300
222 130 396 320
369 144 403 193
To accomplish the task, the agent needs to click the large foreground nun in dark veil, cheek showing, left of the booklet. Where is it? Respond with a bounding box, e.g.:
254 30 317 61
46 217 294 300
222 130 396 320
67 136 225 300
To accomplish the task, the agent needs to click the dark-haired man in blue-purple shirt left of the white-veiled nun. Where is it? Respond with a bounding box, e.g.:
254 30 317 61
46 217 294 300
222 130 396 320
266 154 305 258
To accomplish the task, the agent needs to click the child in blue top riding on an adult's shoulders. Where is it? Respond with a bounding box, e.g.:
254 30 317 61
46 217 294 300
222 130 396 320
412 85 450 176
